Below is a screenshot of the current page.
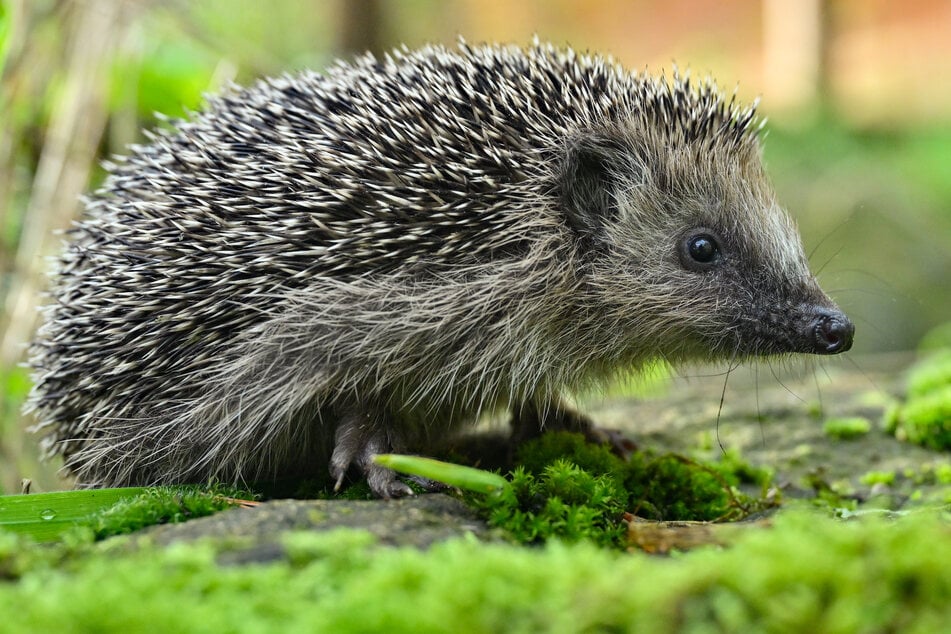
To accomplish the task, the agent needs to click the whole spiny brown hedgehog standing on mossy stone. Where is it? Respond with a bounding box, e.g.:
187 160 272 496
27 40 854 498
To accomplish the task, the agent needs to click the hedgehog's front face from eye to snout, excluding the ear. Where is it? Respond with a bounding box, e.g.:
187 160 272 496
664 206 854 357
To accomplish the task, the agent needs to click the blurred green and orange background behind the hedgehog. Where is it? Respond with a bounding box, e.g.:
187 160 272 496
0 0 951 492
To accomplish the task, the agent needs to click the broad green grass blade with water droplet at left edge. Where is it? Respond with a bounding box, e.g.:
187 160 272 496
0 487 146 542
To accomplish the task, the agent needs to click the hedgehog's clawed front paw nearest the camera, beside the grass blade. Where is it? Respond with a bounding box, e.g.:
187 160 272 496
330 414 413 500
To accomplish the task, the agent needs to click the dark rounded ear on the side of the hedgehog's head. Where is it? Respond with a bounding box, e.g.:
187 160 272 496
561 138 620 241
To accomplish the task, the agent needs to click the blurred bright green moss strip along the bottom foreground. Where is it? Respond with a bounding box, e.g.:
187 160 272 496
0 512 951 634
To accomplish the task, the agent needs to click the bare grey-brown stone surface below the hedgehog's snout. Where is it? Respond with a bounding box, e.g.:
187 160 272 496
583 355 949 506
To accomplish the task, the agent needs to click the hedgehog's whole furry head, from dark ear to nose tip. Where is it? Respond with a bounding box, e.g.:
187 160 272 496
562 127 854 360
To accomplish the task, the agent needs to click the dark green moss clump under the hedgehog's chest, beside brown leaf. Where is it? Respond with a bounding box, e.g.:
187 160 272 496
470 433 770 546
